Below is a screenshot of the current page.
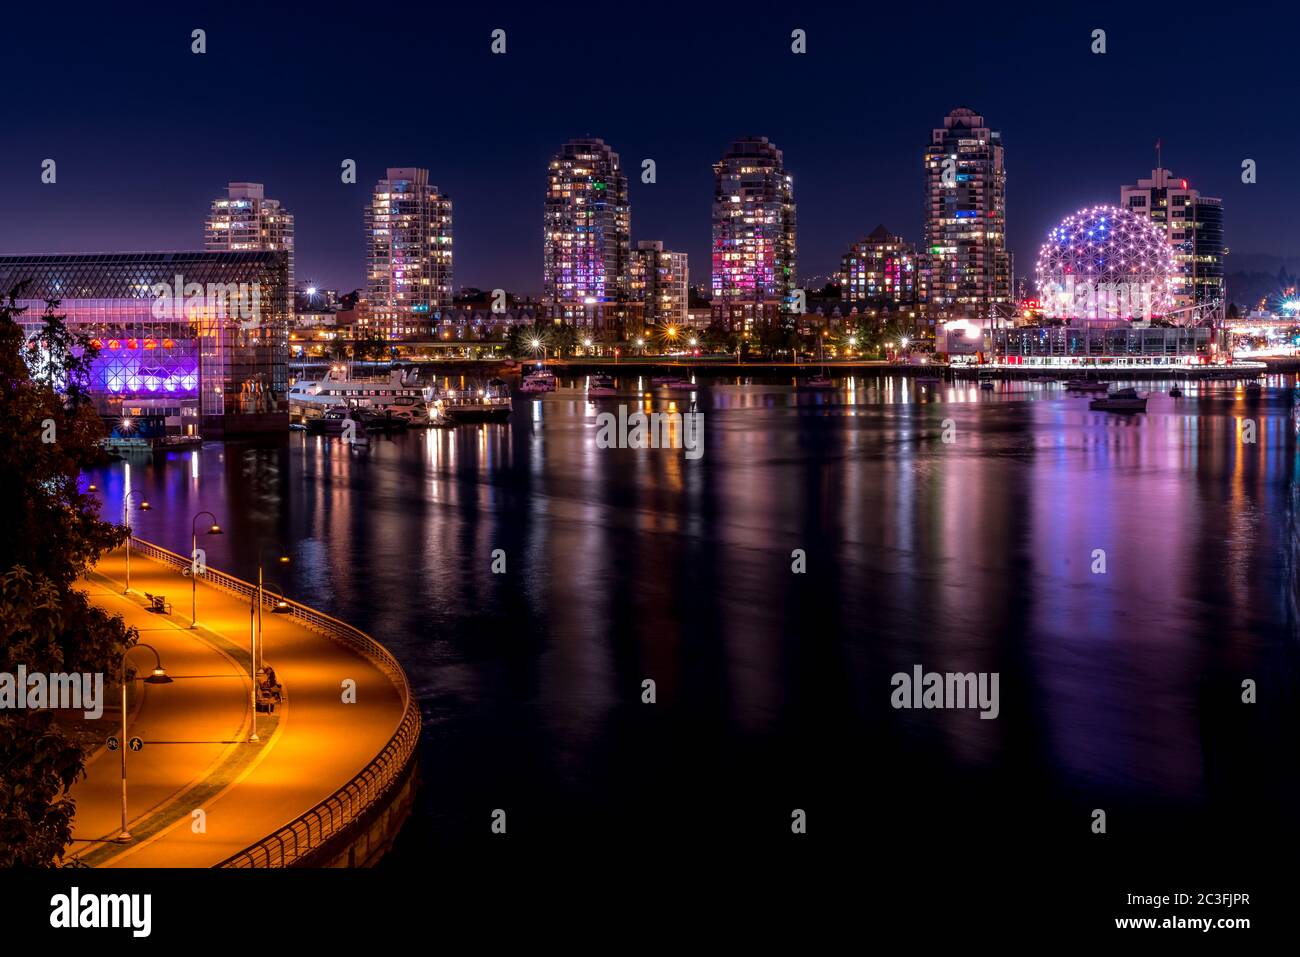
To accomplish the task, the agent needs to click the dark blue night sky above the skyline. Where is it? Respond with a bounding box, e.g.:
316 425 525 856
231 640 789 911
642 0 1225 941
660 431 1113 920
0 0 1300 294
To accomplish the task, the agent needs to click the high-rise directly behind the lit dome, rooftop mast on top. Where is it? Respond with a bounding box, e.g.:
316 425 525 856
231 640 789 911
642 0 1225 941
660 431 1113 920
1119 169 1227 319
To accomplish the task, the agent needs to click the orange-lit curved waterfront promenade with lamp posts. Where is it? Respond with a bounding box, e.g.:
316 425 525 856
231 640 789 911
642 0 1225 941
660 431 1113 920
69 549 419 867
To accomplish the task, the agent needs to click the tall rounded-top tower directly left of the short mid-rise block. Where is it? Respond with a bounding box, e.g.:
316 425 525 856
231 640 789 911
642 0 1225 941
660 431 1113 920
542 138 632 334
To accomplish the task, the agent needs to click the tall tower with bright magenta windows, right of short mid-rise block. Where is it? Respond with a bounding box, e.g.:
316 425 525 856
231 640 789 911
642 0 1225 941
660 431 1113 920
712 137 796 332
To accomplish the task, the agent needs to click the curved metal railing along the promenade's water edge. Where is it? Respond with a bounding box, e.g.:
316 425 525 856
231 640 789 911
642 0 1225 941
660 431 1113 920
130 537 420 867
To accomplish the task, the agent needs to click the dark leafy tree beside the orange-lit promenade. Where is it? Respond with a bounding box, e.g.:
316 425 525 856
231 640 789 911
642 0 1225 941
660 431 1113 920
0 283 137 867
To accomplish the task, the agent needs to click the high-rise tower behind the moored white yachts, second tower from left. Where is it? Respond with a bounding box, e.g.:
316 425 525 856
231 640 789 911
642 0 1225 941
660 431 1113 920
361 166 452 339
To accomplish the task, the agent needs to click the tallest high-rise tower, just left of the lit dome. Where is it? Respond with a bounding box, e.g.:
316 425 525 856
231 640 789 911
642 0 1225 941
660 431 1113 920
919 107 1011 322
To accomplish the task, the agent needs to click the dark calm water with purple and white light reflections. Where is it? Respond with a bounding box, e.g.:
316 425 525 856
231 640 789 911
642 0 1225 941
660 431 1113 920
86 369 1300 866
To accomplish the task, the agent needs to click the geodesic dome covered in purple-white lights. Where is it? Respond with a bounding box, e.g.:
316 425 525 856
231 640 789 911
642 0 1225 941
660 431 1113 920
1036 205 1178 320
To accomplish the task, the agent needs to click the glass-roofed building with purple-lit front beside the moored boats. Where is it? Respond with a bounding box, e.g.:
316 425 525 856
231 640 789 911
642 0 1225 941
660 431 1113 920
0 251 290 438
